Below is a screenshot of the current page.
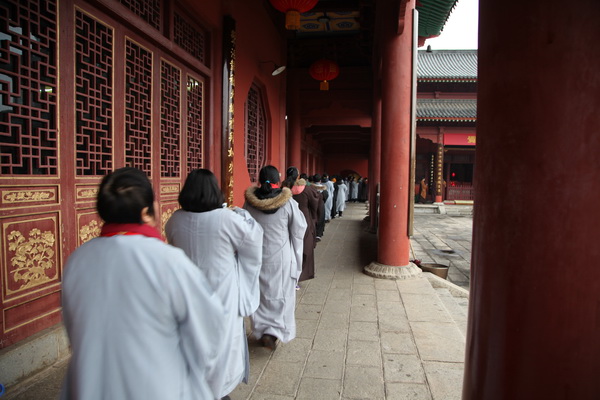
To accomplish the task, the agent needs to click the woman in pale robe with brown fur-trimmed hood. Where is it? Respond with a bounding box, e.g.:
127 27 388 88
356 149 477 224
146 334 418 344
244 165 306 350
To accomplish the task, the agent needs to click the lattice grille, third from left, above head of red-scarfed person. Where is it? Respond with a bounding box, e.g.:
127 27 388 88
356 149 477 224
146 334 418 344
125 40 152 175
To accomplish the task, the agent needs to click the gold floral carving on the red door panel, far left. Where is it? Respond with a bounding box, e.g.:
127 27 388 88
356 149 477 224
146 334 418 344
8 228 56 289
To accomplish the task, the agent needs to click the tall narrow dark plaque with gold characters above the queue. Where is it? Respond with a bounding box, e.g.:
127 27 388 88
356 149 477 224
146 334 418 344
222 16 236 205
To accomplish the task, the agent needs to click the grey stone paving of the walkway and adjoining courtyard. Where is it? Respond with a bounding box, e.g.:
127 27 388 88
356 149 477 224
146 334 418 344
7 204 471 400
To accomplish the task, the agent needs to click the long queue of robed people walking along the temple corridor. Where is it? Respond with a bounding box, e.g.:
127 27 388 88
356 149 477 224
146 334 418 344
61 165 366 399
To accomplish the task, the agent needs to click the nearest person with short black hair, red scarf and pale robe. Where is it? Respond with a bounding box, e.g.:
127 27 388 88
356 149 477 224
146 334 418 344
61 168 225 400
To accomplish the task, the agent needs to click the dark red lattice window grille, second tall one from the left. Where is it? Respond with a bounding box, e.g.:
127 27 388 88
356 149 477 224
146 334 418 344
75 10 113 176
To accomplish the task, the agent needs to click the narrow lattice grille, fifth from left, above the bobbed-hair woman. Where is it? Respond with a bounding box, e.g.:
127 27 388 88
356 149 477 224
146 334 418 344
187 76 204 173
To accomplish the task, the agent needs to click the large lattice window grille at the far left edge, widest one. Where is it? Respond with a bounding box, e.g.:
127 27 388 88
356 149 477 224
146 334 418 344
0 0 58 175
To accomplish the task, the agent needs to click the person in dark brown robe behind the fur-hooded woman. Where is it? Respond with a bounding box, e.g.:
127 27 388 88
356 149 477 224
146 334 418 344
282 167 323 282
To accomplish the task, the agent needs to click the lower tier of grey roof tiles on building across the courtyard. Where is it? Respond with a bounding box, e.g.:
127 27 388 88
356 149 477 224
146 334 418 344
417 99 477 121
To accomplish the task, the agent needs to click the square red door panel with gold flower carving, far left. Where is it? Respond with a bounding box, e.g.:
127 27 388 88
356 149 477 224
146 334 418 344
2 214 60 300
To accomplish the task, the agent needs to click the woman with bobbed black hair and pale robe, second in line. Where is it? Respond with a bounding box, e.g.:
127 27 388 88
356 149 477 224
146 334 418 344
165 169 263 398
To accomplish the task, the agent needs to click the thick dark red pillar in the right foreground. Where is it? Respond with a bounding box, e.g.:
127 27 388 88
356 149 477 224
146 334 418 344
463 0 600 400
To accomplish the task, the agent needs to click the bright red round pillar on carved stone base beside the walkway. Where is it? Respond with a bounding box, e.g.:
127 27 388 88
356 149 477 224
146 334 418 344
365 0 420 279
